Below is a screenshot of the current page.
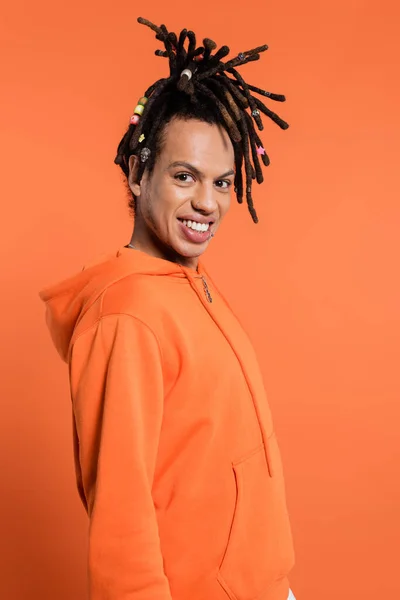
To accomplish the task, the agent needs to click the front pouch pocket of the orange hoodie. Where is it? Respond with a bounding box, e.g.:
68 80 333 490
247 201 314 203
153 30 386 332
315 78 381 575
218 434 294 600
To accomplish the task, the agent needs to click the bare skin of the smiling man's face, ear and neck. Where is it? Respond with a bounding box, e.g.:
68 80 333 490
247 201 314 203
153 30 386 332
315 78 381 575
128 118 234 269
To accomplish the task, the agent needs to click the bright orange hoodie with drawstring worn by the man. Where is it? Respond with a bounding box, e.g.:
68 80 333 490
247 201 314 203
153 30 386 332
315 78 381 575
41 248 293 600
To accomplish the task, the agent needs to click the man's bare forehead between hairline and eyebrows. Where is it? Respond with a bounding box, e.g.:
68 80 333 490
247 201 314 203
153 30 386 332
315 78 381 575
160 119 234 173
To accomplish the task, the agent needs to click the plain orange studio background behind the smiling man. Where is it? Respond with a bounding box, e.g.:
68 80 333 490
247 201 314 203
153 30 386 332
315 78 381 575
0 0 400 600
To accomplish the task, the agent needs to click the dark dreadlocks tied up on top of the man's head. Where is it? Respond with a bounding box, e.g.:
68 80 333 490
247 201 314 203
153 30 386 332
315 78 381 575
114 17 289 223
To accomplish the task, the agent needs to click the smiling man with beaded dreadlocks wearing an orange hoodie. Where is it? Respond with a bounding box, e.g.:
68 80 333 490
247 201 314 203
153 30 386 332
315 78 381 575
41 19 293 600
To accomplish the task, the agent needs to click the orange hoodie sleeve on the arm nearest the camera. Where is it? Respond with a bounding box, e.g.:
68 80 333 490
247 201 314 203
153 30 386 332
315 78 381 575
70 315 171 600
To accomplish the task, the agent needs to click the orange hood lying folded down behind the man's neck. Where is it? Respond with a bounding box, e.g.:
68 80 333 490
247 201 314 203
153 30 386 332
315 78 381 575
39 247 202 362
